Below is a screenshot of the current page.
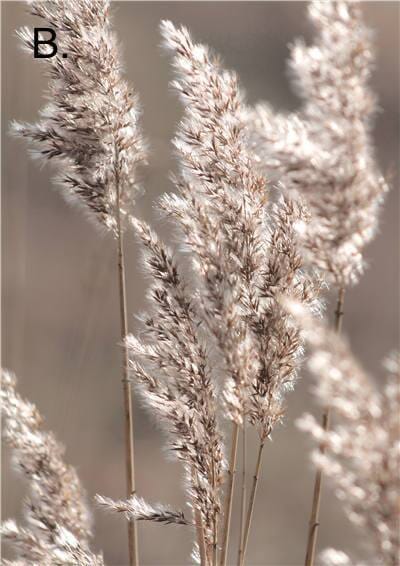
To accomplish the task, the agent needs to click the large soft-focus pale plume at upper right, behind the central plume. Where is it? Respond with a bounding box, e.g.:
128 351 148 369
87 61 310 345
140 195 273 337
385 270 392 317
248 1 387 288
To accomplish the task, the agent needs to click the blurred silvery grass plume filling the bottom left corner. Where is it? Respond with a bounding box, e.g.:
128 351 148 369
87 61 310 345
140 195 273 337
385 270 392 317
1 371 103 566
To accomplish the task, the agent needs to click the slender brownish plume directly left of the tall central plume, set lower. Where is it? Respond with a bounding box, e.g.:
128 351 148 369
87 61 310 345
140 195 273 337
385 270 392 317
127 220 223 555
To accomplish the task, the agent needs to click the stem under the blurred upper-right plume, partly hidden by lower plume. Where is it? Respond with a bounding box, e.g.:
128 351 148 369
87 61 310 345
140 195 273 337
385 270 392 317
304 287 345 566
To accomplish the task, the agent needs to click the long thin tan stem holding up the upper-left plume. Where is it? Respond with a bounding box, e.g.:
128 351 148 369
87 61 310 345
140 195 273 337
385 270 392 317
115 159 139 566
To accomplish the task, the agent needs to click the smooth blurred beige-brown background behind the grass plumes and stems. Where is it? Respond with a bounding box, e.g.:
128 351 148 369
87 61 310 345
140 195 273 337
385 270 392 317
2 2 399 566
